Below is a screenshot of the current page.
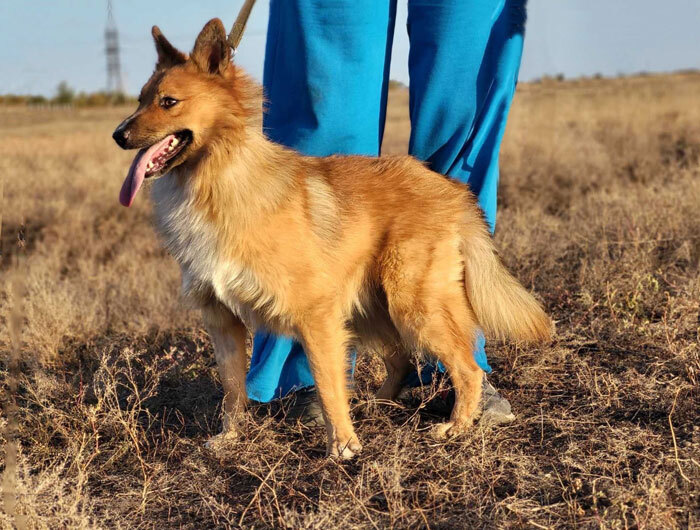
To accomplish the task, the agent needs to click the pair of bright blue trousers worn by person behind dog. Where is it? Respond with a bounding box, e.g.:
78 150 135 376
246 0 526 402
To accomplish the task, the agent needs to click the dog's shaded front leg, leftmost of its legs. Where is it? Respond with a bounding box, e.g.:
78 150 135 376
202 303 248 449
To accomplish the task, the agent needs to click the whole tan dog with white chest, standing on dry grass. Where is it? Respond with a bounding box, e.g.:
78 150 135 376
113 19 552 459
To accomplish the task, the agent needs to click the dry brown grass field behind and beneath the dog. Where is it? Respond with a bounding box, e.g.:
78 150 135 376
0 74 700 529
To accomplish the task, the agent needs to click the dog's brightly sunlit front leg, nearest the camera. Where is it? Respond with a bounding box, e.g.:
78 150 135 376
300 309 362 459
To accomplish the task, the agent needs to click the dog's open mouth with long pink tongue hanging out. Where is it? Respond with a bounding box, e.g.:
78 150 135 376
119 130 192 207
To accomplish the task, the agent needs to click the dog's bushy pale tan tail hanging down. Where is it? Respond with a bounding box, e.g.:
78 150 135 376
462 219 553 342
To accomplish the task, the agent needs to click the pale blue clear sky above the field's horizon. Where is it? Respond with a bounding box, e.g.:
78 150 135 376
0 0 700 95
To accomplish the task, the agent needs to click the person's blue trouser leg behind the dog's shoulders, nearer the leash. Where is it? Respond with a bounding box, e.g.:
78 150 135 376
246 0 396 402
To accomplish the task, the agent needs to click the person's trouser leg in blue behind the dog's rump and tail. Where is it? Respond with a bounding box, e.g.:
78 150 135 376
408 0 526 376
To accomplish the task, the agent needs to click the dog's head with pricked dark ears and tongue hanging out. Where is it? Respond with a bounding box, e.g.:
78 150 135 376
112 18 254 206
